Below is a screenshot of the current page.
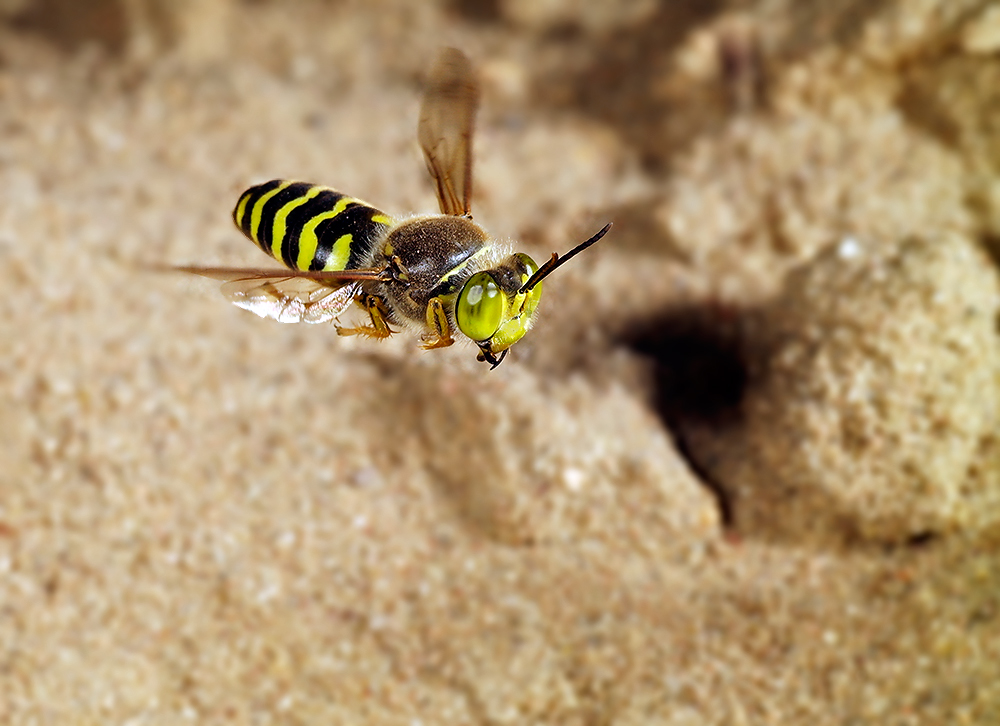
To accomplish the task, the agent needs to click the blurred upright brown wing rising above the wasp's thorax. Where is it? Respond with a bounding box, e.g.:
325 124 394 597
417 48 479 216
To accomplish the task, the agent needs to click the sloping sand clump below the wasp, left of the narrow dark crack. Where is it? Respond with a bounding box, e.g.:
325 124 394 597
371 366 718 548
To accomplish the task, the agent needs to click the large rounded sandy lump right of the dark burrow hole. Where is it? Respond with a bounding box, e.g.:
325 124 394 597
697 234 1000 541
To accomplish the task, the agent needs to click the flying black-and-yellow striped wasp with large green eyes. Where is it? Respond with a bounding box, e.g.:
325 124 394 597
174 48 611 368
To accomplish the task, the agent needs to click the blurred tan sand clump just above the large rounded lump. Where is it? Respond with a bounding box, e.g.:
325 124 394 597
657 102 969 299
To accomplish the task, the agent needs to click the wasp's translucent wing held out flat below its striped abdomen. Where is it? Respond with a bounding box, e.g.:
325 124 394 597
171 267 387 323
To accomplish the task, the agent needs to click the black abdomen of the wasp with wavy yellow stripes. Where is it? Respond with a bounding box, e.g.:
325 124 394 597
233 179 392 270
